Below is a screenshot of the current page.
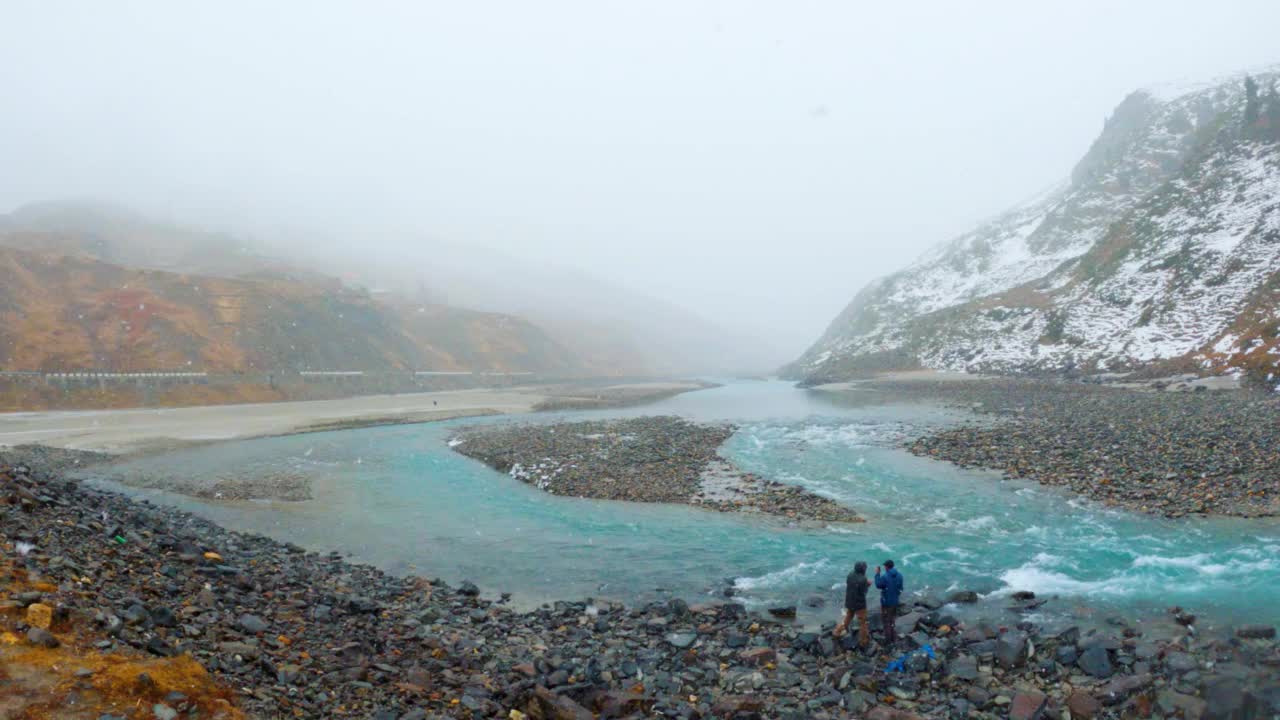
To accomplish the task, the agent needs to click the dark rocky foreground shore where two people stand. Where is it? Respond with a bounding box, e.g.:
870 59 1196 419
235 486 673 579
0 450 1280 720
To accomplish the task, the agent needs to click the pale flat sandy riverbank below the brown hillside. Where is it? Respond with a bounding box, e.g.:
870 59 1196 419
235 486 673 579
0 382 707 454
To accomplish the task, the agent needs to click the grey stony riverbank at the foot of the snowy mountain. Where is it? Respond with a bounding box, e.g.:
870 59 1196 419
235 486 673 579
824 378 1280 518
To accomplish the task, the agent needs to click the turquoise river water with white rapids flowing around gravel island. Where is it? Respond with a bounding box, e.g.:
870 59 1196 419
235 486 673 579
90 382 1280 625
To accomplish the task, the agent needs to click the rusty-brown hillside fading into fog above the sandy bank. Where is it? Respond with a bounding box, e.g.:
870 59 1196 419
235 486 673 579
0 247 576 374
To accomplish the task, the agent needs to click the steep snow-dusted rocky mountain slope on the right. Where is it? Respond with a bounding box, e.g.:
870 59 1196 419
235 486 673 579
785 70 1280 384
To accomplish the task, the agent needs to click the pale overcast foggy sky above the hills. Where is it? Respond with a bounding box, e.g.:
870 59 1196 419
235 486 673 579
0 0 1280 356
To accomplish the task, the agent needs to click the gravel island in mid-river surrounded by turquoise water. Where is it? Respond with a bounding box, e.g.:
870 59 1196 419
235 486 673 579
449 416 861 523
